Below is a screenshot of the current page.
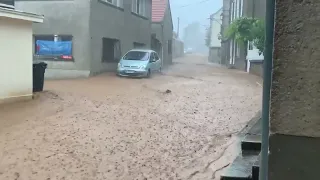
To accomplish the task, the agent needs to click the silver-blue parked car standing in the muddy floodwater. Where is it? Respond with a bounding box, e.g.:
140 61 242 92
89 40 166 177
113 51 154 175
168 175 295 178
117 49 162 77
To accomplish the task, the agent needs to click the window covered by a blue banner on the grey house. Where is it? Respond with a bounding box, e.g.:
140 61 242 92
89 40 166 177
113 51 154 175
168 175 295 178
34 35 74 61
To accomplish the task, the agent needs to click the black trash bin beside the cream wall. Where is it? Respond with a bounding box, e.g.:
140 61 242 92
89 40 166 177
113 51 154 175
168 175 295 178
33 62 47 92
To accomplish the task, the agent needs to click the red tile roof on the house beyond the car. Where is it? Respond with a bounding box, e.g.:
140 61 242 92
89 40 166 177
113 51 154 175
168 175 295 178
152 0 168 22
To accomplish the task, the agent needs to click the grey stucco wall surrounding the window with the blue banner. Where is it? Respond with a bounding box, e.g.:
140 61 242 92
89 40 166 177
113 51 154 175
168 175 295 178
16 0 90 75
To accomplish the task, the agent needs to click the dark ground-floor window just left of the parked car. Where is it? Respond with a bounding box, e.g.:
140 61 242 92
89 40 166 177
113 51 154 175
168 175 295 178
102 38 121 62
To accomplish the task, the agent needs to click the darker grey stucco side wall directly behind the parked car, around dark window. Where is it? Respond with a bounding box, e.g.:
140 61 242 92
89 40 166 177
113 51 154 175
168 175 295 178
90 0 151 73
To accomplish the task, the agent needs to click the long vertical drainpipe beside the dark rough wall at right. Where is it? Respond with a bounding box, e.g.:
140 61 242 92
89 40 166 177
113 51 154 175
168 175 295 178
259 0 275 180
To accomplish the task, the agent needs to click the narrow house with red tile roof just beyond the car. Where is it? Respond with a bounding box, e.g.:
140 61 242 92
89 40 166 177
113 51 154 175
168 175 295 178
151 0 173 66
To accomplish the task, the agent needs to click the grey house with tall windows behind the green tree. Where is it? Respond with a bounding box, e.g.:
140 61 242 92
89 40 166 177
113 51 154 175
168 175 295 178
221 0 266 71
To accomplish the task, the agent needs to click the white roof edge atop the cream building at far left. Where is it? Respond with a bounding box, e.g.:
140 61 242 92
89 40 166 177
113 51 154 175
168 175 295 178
0 8 44 23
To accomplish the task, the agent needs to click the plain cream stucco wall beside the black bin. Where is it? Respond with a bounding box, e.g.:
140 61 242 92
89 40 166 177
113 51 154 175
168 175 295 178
0 17 32 103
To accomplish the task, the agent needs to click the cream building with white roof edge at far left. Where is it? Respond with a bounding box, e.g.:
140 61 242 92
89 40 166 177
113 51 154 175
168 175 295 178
0 0 43 104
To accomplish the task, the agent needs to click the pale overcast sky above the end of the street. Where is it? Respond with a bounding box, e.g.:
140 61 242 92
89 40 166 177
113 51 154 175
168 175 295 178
170 0 222 35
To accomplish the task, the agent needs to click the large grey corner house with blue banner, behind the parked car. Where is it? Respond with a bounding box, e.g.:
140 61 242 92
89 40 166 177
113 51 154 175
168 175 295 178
16 0 152 79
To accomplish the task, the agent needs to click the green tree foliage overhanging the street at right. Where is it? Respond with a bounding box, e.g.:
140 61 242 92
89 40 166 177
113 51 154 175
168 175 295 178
225 17 265 53
